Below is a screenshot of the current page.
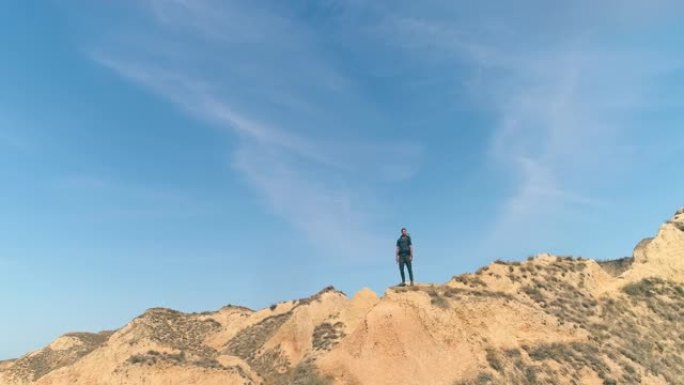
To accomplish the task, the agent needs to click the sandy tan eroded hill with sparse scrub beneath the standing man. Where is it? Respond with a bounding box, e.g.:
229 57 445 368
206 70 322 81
0 210 684 385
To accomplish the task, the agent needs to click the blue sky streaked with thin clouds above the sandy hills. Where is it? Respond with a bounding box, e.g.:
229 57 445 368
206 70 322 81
0 0 684 359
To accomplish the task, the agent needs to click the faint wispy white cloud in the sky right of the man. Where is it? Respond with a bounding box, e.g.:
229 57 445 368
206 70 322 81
368 2 683 252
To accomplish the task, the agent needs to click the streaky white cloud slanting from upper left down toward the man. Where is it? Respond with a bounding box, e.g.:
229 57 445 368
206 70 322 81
91 1 420 258
